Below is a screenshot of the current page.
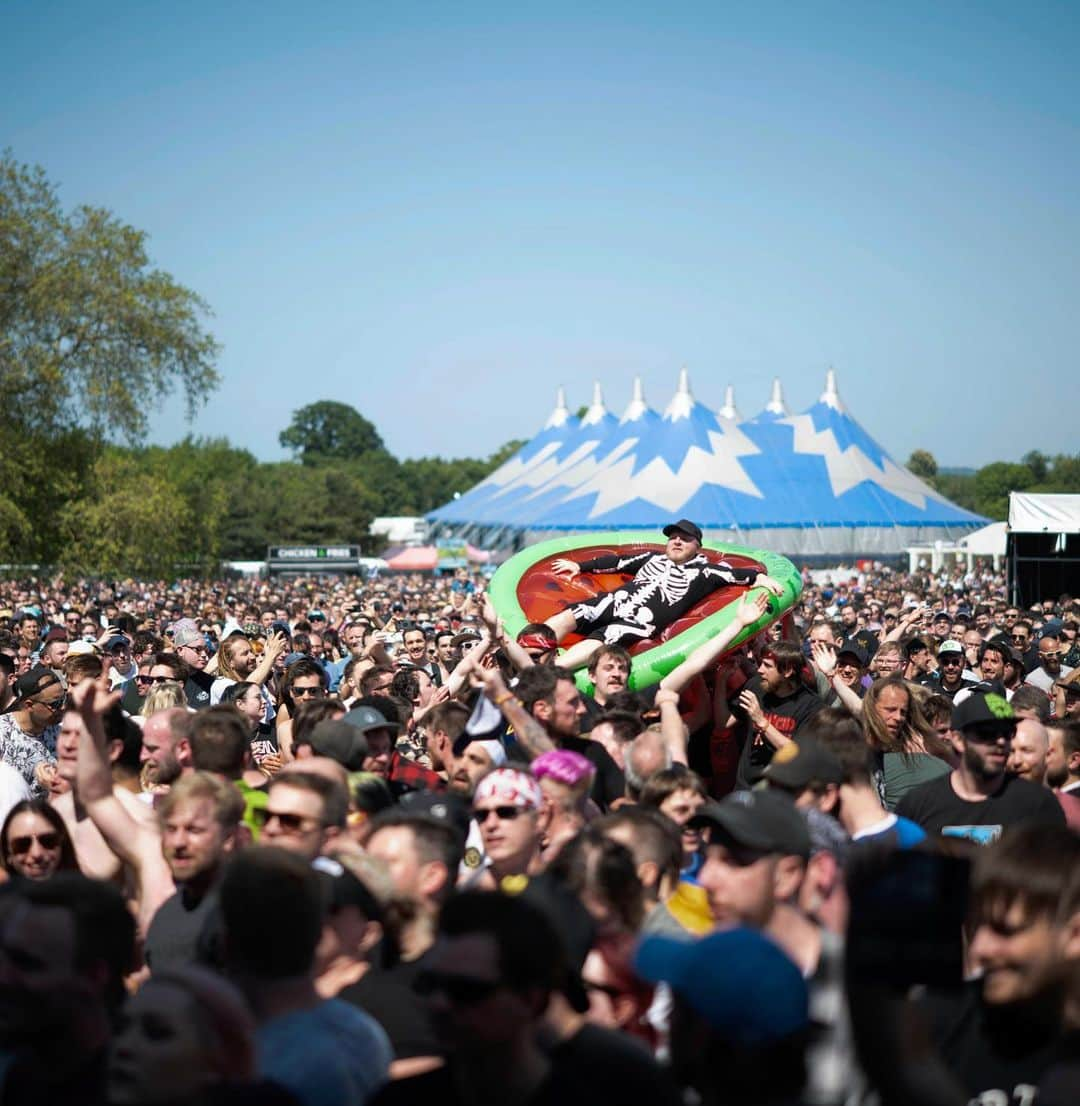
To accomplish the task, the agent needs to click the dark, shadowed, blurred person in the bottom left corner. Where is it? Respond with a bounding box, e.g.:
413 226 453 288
0 872 135 1106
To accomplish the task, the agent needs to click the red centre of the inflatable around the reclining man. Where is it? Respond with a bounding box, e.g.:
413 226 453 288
517 544 766 654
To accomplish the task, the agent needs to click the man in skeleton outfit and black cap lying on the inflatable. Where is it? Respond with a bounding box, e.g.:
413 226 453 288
548 519 783 669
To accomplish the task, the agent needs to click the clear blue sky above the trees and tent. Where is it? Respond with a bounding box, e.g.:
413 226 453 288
0 0 1080 465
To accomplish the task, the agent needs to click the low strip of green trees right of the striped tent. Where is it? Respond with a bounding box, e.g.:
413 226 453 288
907 449 1080 520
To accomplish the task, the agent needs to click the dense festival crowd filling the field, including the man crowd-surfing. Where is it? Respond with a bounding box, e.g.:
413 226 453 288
0 520 1080 1106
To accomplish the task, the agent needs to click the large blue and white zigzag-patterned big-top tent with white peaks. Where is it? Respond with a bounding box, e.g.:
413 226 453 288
428 369 986 557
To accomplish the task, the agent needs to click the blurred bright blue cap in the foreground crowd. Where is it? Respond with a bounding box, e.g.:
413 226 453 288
634 927 810 1045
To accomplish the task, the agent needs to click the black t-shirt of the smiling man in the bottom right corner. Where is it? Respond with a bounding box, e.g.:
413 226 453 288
918 982 1067 1106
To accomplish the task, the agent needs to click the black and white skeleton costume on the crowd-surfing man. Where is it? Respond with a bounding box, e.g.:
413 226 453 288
570 553 759 645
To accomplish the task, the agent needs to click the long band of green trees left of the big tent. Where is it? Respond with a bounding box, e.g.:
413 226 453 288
0 403 521 577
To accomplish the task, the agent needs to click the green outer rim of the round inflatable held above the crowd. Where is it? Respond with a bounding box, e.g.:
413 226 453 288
488 530 802 692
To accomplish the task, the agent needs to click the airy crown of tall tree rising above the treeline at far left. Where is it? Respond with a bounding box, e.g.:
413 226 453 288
0 150 218 441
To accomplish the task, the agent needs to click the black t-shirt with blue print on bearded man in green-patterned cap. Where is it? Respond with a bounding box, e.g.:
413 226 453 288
896 772 1065 845
